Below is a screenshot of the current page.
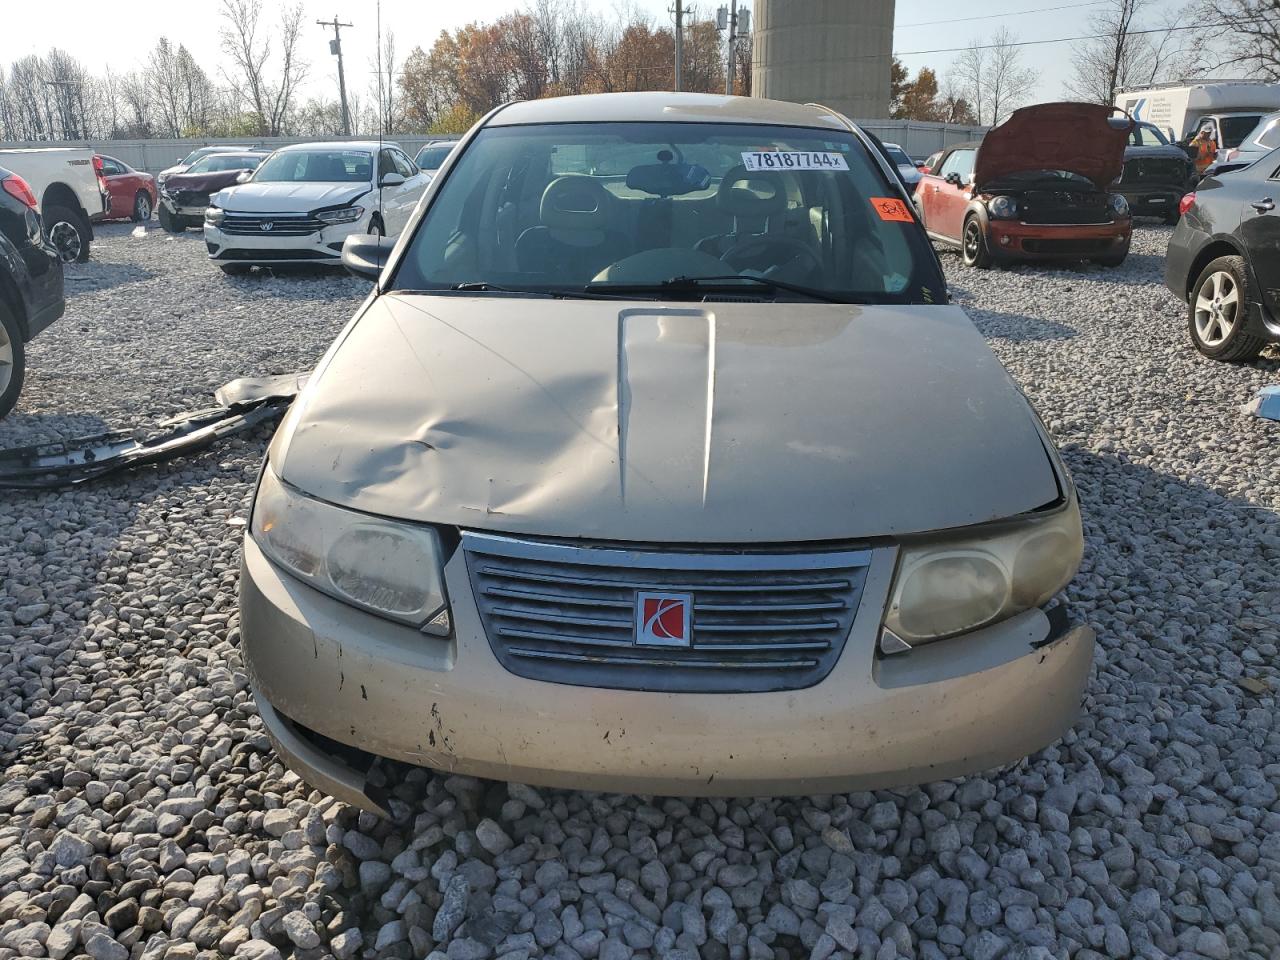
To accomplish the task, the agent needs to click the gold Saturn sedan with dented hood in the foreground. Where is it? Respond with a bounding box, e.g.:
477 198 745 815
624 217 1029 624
240 93 1090 810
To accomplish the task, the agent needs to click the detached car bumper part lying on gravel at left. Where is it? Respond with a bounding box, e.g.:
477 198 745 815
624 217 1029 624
0 374 308 490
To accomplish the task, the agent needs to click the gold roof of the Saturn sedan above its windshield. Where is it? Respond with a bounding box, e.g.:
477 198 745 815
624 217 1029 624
486 91 849 131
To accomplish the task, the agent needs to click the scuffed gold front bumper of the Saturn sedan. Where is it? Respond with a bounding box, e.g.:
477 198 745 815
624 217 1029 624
241 538 1093 810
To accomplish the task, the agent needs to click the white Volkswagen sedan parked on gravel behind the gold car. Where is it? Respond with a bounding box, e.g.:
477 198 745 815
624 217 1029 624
205 141 431 274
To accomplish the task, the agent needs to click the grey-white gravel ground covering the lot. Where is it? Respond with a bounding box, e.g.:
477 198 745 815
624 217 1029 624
0 227 1280 960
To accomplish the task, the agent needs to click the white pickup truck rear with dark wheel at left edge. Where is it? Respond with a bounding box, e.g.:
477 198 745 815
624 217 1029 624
0 147 109 264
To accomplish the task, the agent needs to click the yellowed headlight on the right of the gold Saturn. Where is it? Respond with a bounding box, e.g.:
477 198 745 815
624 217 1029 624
884 495 1084 646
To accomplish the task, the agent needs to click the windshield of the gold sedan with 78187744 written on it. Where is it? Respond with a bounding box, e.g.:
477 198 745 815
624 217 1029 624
392 123 946 303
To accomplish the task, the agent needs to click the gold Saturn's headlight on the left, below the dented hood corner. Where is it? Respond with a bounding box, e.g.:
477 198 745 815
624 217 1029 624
250 466 452 636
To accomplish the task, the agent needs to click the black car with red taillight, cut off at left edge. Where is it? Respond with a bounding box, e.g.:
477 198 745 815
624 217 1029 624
0 168 64 417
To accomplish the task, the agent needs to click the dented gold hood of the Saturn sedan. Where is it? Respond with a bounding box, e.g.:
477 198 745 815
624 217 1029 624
270 294 1059 543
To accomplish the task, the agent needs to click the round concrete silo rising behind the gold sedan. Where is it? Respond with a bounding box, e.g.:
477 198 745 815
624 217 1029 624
751 0 893 119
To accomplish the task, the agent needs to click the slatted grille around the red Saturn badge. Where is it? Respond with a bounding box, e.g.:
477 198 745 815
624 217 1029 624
462 532 870 692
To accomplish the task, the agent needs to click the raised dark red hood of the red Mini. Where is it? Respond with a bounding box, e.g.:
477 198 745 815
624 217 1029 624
973 104 1133 191
